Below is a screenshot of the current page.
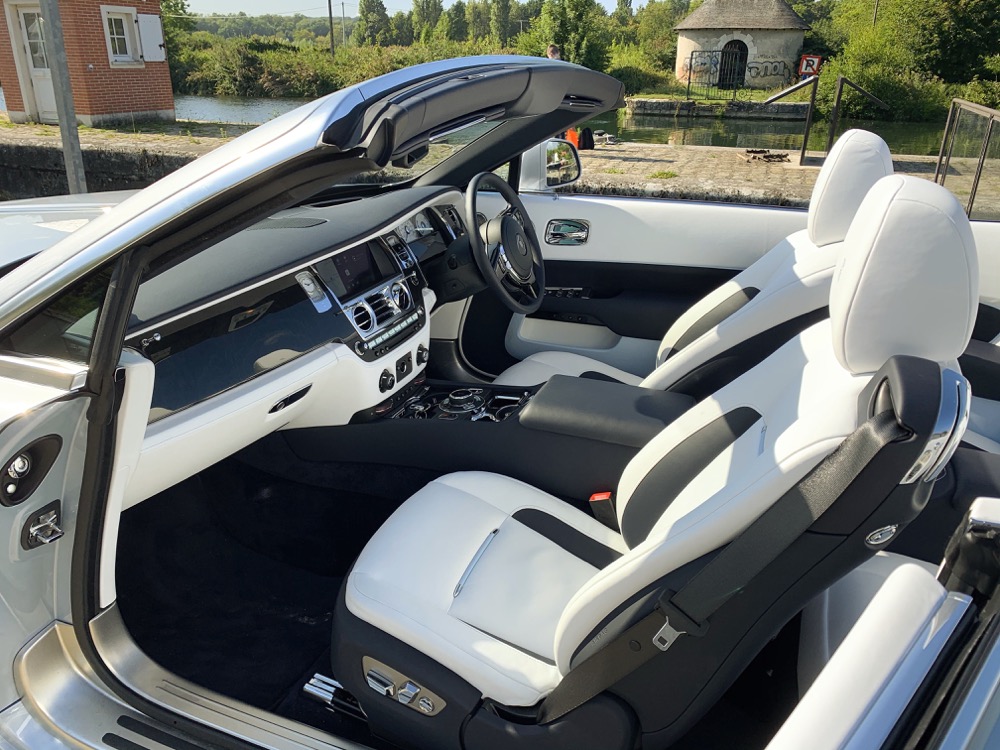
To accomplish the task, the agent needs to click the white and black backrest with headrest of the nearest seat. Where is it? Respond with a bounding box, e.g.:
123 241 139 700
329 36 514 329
555 176 979 672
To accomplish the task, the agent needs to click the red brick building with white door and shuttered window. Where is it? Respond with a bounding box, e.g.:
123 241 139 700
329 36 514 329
0 0 174 125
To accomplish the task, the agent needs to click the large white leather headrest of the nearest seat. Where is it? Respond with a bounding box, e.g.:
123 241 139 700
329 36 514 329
830 175 979 373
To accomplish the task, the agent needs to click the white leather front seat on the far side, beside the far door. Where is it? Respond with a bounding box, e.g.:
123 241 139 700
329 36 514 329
494 130 892 389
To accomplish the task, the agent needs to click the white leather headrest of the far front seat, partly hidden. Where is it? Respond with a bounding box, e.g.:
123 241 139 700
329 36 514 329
806 130 892 247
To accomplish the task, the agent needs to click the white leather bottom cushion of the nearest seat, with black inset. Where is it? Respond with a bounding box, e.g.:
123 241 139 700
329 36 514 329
345 472 626 706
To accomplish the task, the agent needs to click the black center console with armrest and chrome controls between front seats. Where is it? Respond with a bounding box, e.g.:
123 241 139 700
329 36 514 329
308 374 694 502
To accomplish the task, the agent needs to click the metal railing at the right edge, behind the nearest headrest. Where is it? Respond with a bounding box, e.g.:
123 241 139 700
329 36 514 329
934 99 1000 221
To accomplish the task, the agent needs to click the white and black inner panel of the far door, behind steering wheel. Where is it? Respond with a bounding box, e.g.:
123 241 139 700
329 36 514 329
472 193 807 375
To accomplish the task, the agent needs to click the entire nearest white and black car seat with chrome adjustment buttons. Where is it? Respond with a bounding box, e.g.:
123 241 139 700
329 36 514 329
332 177 979 750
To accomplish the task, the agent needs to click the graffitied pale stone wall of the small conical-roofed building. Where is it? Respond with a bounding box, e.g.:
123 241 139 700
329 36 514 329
675 29 805 89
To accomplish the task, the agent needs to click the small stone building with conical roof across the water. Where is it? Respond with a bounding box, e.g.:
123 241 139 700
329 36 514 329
674 0 809 89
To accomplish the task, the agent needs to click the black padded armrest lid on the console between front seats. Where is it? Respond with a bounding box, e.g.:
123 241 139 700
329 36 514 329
519 375 695 448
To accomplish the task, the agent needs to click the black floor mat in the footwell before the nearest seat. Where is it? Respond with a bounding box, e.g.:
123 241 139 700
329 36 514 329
117 477 342 709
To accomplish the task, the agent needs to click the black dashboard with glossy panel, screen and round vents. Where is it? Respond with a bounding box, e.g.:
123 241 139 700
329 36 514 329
126 187 465 422
